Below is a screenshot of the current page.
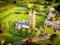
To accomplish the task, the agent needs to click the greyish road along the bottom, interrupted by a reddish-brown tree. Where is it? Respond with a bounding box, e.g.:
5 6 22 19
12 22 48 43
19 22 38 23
12 35 50 45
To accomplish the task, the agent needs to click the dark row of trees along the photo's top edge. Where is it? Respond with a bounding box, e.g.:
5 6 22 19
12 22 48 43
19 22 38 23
0 0 60 6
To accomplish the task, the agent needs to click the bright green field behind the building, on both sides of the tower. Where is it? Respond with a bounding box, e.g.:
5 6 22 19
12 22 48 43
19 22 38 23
0 7 44 27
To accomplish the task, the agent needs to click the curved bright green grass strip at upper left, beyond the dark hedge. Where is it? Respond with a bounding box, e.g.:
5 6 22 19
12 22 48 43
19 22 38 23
0 7 26 19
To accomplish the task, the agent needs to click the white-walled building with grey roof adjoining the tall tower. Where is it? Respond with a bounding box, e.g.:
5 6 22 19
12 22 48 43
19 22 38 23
15 20 29 30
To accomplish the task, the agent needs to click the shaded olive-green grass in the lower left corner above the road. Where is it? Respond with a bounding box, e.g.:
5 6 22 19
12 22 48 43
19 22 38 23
0 33 23 43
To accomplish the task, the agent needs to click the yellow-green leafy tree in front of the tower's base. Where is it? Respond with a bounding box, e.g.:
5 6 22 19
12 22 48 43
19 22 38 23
27 28 40 38
